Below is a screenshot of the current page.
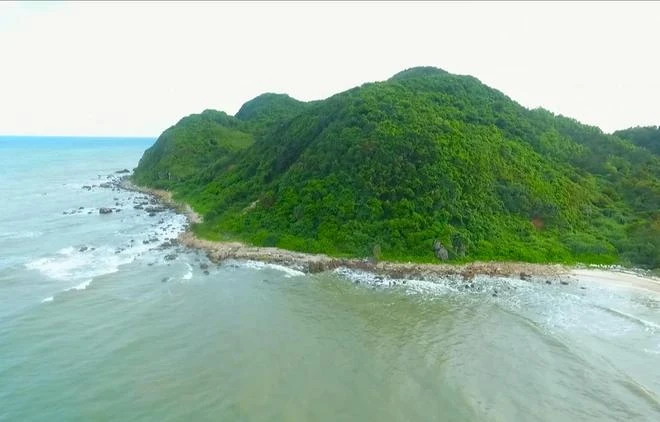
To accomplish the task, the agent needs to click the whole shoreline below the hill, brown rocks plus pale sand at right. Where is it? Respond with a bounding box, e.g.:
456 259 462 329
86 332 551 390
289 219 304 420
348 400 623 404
119 177 660 294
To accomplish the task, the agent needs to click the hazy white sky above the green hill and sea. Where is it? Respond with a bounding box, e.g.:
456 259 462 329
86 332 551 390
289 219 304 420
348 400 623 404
0 2 660 136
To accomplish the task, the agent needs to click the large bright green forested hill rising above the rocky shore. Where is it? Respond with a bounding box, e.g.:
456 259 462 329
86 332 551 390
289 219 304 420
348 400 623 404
133 67 660 267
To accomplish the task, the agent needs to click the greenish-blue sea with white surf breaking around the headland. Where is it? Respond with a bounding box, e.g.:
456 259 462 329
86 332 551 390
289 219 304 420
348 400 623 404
0 137 660 422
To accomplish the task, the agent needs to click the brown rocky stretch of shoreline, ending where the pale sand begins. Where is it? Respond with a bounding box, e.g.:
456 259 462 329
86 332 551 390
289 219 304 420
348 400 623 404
117 176 570 284
